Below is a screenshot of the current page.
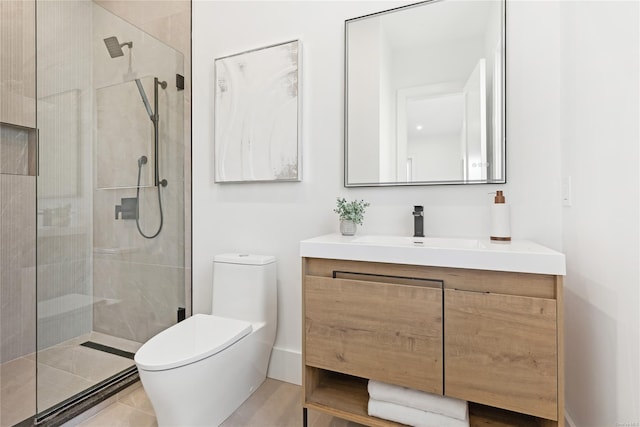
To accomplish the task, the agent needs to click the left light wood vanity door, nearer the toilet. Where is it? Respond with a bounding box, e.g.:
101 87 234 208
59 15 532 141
304 276 442 394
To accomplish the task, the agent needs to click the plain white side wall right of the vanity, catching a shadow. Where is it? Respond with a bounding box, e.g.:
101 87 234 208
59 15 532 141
560 1 640 427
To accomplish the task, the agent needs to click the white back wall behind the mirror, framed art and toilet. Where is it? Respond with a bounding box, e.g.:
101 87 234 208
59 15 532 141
193 1 562 388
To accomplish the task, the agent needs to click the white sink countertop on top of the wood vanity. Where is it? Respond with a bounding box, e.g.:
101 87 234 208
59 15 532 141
300 234 566 275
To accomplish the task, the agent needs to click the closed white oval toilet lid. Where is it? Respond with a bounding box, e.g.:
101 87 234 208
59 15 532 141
134 314 251 371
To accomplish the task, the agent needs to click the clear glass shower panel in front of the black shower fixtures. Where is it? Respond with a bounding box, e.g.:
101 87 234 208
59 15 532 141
36 0 185 414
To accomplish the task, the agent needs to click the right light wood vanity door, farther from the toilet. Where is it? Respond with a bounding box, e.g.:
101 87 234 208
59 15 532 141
444 289 558 420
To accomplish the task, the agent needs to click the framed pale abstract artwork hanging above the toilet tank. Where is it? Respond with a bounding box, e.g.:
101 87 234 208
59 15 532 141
214 40 302 183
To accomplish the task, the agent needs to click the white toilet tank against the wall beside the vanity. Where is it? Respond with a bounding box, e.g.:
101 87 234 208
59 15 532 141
212 254 277 325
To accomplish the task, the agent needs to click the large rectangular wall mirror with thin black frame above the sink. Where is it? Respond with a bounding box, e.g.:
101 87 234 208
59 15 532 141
345 0 506 187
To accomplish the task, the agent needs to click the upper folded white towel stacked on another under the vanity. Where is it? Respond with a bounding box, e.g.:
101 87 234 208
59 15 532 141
367 380 467 420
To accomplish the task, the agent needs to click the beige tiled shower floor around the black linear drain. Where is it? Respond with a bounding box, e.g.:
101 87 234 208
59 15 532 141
0 332 141 427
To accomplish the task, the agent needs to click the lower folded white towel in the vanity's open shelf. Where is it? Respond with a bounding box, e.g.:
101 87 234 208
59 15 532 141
368 399 469 427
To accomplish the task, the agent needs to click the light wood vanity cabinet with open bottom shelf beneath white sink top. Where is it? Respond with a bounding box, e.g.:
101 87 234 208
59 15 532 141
301 236 564 426
